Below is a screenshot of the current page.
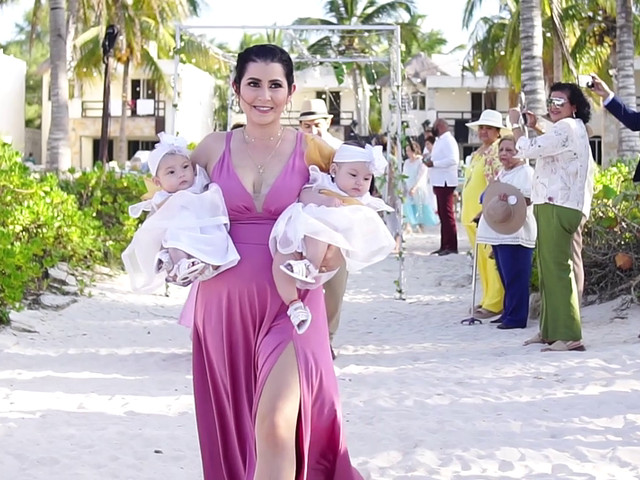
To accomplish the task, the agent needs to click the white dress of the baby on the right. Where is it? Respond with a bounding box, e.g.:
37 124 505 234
269 166 395 281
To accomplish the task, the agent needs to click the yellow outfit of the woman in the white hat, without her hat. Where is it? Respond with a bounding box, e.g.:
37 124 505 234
461 140 504 313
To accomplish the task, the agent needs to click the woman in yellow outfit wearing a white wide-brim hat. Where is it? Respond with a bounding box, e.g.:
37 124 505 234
461 110 509 320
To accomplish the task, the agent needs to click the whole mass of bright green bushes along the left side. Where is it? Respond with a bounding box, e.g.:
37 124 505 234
0 143 146 324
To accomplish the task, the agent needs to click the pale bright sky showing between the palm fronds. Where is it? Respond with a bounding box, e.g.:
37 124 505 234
0 0 499 55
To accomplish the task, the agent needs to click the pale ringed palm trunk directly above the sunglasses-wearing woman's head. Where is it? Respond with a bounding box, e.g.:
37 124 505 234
520 0 546 115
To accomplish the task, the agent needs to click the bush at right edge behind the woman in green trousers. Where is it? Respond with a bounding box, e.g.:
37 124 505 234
583 160 640 300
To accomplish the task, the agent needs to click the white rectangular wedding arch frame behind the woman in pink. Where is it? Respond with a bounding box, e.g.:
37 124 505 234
172 23 405 300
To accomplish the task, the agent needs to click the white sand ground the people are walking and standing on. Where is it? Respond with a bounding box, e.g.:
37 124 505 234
0 230 640 480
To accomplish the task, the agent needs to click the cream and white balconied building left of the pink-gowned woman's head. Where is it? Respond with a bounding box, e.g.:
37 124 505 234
42 60 215 168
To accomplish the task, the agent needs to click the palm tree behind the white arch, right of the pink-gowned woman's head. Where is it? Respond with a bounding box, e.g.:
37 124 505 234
294 0 415 135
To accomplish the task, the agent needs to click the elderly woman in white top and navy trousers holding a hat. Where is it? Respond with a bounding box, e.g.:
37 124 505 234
477 135 536 330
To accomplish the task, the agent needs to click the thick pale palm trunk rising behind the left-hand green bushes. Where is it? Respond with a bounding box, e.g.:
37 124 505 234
45 0 71 170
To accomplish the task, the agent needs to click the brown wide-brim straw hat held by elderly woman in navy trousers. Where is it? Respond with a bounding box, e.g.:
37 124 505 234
482 182 527 235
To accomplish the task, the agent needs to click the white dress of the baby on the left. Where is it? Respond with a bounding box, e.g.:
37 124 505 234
122 166 240 292
